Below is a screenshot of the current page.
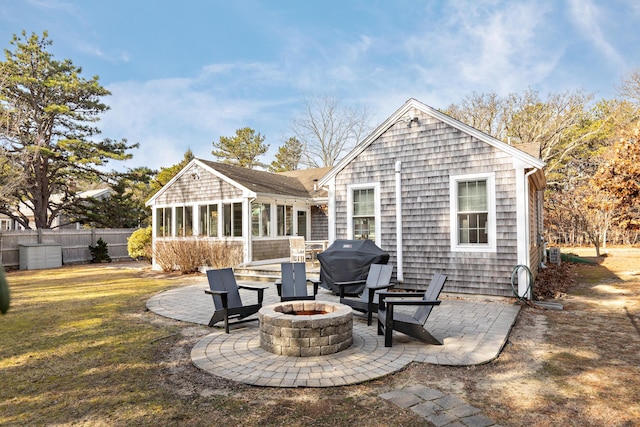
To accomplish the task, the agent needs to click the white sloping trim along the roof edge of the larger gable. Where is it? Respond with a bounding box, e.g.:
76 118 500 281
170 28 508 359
318 98 545 186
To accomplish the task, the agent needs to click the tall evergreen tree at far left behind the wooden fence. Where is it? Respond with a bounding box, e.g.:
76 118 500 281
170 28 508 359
0 31 137 229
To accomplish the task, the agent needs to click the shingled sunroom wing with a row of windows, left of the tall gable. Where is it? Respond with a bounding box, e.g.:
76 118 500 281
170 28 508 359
147 159 329 264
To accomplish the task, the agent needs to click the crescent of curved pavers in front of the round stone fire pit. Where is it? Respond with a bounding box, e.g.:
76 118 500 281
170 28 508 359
191 322 417 387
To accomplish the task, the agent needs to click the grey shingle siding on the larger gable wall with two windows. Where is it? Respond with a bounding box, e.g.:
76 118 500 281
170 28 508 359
323 101 544 296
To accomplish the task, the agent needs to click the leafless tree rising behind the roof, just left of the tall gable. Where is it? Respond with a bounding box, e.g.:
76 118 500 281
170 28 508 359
292 95 372 167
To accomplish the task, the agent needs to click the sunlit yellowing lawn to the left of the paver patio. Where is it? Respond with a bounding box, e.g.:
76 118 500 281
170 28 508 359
0 264 428 426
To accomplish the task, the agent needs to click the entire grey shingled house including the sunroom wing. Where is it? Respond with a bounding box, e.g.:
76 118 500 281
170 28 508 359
147 99 546 296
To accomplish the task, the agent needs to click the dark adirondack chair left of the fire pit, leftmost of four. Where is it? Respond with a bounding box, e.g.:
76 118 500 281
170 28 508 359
205 268 266 334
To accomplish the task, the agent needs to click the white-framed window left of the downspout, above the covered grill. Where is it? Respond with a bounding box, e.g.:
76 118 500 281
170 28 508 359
347 183 380 245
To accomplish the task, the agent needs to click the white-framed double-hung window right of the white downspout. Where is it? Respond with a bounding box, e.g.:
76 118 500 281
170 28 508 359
450 174 496 252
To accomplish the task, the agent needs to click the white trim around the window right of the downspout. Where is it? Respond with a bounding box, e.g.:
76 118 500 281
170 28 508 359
449 173 497 252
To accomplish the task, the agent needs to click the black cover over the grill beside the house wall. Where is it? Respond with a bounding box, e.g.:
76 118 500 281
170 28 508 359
318 240 389 295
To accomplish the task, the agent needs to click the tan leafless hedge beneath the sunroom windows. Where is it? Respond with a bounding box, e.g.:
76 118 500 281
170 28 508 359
154 240 242 273
